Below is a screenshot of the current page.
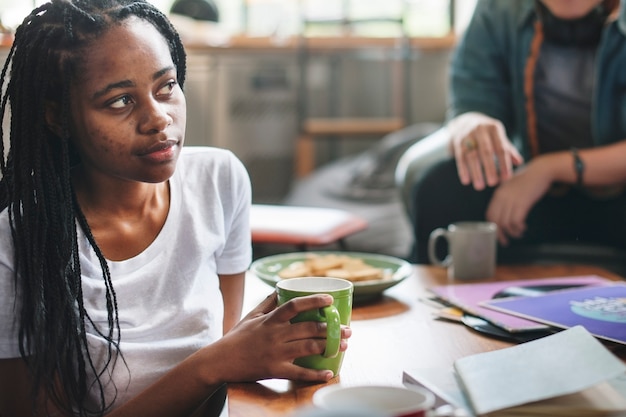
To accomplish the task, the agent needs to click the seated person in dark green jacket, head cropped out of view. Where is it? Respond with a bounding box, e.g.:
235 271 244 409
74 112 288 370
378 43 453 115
397 0 626 263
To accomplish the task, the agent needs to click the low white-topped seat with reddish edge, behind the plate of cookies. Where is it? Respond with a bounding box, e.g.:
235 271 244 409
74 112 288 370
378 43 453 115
250 204 368 250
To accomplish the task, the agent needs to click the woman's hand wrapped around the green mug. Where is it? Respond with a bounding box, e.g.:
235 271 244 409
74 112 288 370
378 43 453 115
206 294 352 382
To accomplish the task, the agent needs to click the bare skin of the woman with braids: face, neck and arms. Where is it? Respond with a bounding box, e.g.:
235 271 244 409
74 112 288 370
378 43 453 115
0 18 351 417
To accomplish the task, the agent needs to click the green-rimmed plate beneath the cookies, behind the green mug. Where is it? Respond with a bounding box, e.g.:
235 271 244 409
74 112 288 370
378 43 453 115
250 252 413 301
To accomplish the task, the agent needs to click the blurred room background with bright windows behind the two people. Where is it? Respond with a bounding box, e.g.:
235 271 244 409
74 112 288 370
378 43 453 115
0 0 475 256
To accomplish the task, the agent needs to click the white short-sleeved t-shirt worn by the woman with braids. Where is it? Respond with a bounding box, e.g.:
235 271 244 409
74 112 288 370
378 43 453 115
0 147 252 406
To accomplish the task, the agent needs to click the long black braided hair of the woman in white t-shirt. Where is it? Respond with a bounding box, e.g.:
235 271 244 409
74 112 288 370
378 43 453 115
0 0 186 416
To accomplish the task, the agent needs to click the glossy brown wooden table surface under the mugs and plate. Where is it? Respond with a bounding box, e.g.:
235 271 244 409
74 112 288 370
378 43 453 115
228 265 626 417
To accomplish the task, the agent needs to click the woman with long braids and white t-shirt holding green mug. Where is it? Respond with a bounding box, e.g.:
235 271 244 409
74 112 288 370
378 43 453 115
0 0 351 417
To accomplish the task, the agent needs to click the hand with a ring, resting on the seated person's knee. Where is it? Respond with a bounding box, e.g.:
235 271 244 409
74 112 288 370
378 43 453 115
447 112 524 190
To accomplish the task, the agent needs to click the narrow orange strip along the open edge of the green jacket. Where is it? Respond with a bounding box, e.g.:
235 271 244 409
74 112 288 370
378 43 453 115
524 20 543 156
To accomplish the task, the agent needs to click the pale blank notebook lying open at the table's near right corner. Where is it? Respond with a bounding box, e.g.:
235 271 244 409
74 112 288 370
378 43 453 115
404 326 626 416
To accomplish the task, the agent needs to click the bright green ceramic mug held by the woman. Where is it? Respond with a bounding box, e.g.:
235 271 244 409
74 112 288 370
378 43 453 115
276 277 354 376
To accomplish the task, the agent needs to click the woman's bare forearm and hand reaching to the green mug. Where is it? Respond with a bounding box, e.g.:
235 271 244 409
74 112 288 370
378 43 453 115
0 293 352 417
